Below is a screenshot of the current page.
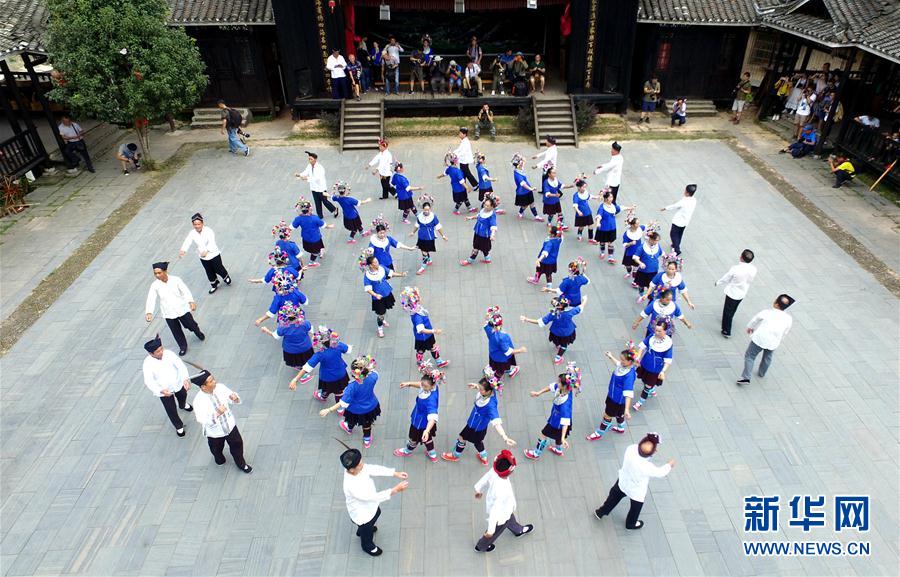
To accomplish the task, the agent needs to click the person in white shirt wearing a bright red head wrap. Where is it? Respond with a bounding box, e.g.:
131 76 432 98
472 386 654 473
475 449 534 553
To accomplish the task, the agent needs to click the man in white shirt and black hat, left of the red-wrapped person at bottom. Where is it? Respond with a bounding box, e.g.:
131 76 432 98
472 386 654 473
341 443 409 557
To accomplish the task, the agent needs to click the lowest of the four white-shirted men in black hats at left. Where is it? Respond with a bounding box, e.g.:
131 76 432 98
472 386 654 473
190 369 253 473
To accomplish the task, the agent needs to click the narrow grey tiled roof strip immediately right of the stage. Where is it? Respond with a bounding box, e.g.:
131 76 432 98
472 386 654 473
638 0 757 26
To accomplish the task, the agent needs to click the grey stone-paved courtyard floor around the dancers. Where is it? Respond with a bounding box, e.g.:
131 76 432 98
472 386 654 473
0 139 900 575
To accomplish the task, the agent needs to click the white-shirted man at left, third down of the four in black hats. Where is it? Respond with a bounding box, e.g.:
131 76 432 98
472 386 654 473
143 335 194 437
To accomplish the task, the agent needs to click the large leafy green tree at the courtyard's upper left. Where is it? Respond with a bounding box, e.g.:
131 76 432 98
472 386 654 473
47 0 207 158
